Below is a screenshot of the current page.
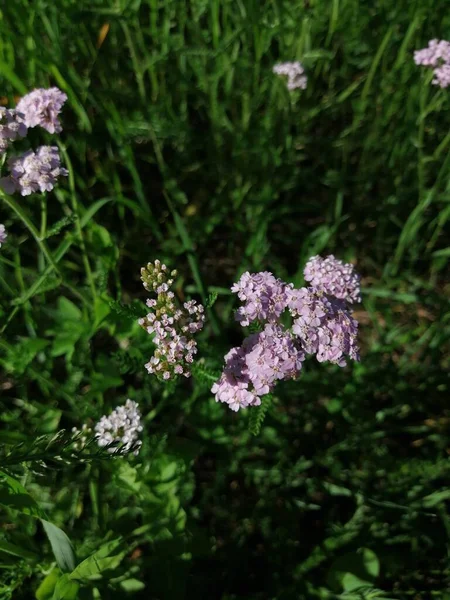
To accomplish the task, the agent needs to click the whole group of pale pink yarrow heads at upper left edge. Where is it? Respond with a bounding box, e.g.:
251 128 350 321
0 87 68 196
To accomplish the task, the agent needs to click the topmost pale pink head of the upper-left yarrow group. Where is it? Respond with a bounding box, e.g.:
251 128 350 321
16 87 67 133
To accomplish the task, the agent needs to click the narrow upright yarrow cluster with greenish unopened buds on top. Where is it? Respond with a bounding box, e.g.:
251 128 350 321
139 260 205 380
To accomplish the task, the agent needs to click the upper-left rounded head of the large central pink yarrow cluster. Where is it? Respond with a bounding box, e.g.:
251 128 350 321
231 271 289 327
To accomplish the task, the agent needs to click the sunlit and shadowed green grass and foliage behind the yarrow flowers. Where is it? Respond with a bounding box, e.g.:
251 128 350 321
0 0 450 600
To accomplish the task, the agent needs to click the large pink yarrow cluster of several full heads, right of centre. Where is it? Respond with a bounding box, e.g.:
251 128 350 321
211 256 360 411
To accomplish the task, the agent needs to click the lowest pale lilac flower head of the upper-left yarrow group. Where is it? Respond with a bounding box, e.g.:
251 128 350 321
0 146 69 196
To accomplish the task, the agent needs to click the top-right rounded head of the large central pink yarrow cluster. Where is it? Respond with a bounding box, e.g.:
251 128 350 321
303 254 361 304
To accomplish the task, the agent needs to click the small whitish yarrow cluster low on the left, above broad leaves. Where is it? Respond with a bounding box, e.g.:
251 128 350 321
72 399 142 456
